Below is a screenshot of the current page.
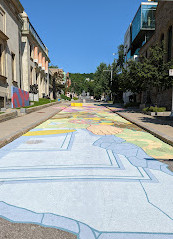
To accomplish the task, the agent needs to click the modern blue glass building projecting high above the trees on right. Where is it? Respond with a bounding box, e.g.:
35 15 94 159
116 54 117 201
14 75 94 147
124 2 158 61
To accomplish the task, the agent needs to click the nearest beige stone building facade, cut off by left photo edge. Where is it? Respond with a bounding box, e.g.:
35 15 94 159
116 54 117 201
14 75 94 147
0 0 24 108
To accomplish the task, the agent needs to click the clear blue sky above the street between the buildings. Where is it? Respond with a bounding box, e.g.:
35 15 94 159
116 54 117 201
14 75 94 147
21 0 147 73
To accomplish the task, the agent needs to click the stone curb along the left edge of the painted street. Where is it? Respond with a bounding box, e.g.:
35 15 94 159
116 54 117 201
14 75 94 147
0 105 69 148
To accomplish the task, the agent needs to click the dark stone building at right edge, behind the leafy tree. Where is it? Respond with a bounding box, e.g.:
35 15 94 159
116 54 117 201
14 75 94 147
139 1 173 110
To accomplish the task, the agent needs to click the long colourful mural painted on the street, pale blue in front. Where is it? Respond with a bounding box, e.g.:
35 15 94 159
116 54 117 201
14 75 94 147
0 104 173 239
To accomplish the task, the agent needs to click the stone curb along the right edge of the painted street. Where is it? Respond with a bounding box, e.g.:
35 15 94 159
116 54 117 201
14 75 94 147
106 107 173 146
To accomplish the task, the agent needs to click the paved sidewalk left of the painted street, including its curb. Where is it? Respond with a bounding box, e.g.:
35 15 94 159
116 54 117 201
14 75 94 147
0 103 69 148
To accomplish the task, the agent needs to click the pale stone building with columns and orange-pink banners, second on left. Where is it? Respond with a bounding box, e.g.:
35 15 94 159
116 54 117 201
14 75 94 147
21 12 50 98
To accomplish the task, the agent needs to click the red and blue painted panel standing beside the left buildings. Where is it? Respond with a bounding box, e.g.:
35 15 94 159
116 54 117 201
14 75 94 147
11 86 29 108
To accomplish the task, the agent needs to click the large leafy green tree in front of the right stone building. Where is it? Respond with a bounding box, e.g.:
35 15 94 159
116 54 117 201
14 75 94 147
121 44 173 105
